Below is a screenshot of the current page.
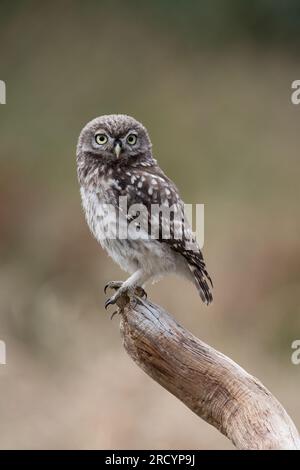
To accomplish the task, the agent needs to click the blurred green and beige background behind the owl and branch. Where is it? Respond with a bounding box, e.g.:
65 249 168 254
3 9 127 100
0 0 300 449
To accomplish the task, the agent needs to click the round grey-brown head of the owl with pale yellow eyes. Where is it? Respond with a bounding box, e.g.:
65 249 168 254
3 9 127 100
77 114 151 161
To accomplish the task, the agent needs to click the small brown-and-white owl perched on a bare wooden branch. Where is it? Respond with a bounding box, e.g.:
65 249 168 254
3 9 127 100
76 114 212 308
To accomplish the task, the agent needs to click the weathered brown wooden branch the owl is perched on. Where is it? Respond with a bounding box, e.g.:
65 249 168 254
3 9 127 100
118 297 300 450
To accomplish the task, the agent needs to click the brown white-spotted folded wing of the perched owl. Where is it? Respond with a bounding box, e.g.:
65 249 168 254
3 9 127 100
126 166 213 304
